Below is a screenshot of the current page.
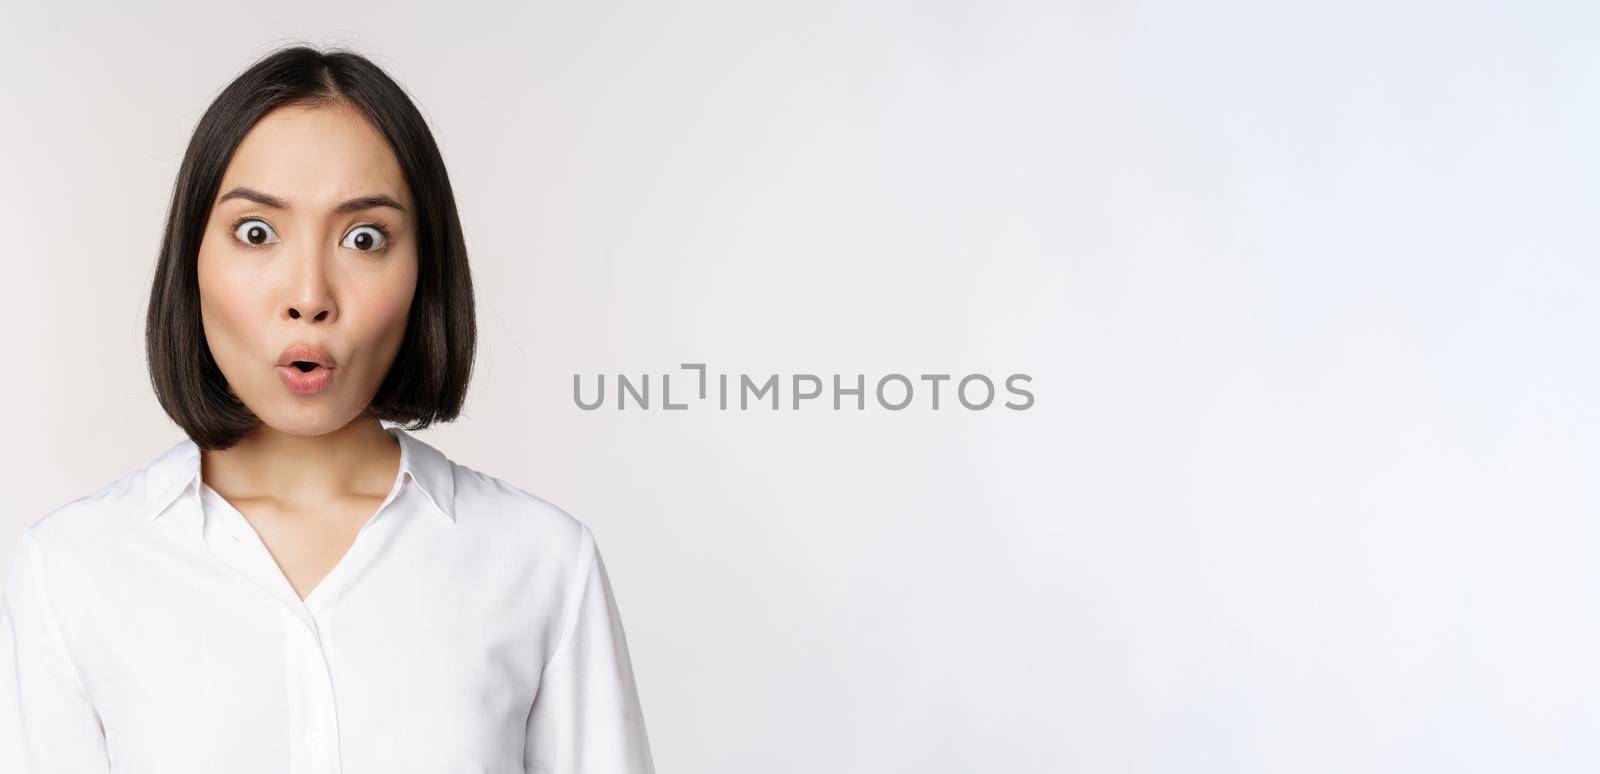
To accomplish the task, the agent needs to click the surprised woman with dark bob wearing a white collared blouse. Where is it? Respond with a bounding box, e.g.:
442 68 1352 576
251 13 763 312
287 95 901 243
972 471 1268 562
0 46 653 774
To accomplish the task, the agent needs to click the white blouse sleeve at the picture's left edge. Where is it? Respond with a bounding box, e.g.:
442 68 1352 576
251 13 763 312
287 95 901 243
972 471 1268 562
0 529 110 774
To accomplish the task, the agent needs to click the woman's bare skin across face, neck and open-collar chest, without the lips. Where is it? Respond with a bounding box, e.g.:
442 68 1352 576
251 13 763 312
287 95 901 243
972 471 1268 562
198 99 418 598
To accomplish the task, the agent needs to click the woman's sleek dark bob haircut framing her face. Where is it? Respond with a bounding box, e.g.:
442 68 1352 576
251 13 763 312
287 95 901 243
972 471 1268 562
144 45 477 449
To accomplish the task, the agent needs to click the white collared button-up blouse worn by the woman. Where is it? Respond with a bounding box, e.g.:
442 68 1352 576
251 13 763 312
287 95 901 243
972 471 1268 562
0 427 653 774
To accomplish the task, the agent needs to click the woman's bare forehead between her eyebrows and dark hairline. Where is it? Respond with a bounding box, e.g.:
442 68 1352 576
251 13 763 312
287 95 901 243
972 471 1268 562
219 106 411 209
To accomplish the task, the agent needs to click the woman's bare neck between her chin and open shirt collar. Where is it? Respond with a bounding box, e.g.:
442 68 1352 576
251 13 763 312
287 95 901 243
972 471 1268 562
200 417 400 510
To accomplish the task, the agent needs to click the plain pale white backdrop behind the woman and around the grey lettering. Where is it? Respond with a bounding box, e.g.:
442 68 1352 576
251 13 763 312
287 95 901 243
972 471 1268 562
0 0 1600 774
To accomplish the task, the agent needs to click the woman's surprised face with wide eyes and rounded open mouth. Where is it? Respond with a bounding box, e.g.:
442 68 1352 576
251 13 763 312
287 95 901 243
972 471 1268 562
198 106 418 435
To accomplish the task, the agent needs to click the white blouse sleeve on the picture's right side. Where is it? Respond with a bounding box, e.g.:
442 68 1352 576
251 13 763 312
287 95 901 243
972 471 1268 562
523 525 656 774
